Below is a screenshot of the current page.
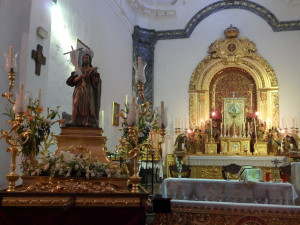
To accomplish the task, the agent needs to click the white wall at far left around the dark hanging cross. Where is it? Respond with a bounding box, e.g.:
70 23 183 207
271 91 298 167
0 0 51 188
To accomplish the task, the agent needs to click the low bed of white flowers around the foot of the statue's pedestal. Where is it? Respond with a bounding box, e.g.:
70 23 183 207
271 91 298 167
22 151 122 179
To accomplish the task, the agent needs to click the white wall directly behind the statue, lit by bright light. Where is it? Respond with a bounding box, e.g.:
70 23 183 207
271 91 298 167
47 0 133 151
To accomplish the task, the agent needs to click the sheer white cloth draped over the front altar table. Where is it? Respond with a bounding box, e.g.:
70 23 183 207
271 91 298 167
160 178 298 205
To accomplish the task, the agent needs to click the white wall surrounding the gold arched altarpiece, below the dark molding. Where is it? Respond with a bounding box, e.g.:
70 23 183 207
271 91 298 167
154 1 300 156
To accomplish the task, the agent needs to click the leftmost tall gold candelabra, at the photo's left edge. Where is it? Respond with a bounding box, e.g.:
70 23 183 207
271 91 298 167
0 68 30 192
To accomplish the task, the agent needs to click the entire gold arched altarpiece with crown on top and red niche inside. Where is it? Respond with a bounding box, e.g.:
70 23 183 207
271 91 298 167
189 26 279 155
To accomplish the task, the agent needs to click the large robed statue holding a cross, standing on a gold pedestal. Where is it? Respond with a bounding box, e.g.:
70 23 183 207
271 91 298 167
66 50 101 127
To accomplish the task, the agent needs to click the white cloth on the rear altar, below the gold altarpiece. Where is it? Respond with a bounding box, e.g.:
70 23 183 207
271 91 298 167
186 155 289 167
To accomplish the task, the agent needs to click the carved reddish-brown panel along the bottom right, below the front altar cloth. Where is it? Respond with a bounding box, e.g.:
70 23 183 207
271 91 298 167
153 200 300 225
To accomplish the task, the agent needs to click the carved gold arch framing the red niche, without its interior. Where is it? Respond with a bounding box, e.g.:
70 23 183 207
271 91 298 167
189 28 279 130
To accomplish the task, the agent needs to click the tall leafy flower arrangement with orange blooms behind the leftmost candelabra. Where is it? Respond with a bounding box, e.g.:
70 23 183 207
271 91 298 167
4 100 63 157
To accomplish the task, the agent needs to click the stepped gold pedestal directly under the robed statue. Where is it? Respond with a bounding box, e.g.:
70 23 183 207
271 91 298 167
55 127 109 163
